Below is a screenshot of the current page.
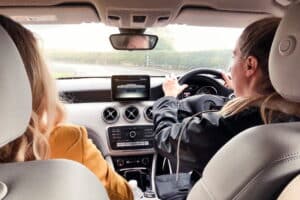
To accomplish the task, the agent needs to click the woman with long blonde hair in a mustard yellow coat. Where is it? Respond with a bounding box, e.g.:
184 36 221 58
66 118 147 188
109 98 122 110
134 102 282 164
0 15 133 200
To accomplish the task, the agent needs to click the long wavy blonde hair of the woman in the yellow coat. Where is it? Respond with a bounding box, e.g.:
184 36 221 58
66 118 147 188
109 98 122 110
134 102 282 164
0 15 65 162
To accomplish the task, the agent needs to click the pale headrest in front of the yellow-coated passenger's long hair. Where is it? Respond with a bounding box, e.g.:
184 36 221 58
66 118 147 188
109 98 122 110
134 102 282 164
0 26 32 147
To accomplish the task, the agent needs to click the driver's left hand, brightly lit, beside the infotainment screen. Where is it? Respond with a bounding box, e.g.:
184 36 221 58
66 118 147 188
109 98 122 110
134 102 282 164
162 75 188 97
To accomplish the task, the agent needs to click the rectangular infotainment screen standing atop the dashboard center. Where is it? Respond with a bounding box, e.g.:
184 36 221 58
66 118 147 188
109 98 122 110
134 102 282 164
111 75 150 101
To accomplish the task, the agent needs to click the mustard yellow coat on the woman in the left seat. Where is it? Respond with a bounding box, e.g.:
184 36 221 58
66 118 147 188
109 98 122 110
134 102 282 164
49 125 133 200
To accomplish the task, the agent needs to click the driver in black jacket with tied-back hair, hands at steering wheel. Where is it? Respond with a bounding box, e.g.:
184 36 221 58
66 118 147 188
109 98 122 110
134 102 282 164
153 18 300 174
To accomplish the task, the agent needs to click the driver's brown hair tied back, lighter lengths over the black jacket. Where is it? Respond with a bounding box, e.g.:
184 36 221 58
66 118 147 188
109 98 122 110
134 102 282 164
220 17 300 123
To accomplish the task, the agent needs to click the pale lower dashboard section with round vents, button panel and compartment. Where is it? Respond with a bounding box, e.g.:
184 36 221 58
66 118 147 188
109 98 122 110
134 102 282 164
66 98 157 194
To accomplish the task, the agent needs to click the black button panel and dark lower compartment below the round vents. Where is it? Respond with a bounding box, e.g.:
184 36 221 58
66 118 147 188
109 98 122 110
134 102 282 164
107 125 154 191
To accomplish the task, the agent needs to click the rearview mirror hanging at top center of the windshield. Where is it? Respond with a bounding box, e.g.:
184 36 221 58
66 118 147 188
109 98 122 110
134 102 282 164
109 33 158 50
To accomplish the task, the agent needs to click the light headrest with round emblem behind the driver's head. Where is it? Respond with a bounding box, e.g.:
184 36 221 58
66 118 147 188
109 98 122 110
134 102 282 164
269 3 300 102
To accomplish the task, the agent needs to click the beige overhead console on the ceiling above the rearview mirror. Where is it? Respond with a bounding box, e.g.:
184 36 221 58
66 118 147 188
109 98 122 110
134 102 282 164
98 0 183 29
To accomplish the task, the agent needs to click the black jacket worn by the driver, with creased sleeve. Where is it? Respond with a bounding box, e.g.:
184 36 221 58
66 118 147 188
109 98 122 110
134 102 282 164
153 97 263 173
